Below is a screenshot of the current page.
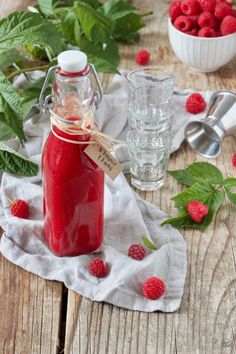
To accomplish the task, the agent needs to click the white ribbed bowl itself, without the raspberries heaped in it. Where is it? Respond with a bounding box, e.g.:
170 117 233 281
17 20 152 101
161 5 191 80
168 19 236 73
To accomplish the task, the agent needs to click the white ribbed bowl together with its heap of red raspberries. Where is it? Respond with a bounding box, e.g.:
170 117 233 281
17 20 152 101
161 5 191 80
168 0 236 72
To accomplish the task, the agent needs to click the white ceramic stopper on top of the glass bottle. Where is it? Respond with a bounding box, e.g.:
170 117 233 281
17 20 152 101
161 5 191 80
57 50 88 73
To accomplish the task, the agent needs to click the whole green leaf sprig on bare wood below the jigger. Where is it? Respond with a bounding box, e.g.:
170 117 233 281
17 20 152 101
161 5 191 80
162 162 236 231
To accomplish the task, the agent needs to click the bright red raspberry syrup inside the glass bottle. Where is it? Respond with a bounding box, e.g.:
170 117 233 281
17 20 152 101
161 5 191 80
42 117 104 256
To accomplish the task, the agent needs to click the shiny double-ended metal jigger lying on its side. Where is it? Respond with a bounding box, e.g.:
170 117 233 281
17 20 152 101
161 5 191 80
185 91 236 158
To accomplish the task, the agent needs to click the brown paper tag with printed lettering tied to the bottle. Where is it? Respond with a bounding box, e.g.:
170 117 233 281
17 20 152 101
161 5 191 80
84 142 123 181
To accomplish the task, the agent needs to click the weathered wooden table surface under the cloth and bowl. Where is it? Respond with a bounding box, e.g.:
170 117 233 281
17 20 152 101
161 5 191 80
0 0 236 354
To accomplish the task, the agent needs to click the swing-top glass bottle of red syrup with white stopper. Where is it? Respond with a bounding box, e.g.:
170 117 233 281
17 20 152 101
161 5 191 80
40 50 104 256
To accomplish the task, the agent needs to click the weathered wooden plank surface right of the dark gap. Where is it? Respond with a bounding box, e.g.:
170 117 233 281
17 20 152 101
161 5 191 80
65 0 236 354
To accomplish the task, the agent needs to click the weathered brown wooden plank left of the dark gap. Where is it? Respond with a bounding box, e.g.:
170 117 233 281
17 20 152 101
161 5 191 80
0 0 62 354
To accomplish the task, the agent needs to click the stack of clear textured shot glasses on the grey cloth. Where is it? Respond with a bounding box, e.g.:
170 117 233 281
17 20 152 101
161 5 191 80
127 68 174 190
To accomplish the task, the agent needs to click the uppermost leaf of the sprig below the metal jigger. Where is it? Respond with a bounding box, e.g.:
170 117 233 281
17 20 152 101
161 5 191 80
168 162 223 186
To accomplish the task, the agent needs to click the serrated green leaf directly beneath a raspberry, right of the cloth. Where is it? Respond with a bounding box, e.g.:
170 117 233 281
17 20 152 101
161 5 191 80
163 182 224 231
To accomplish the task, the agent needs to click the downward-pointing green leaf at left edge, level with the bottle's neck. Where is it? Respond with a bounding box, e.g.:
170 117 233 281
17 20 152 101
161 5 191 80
0 71 25 142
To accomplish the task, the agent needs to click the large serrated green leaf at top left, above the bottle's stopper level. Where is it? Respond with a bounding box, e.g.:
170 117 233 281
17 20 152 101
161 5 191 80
0 12 62 55
